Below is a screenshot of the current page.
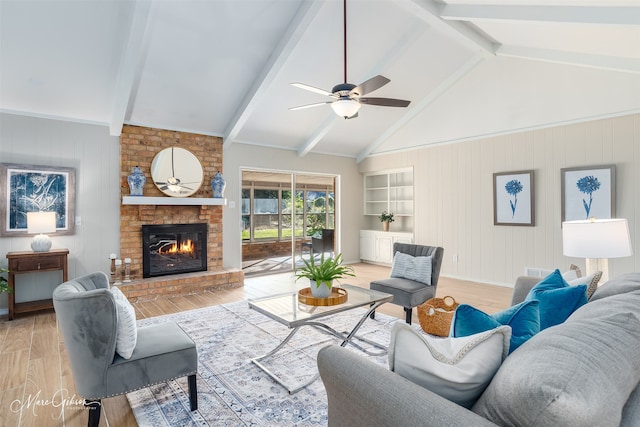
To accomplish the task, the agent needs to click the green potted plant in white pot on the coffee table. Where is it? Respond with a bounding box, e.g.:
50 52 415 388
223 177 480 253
296 253 355 298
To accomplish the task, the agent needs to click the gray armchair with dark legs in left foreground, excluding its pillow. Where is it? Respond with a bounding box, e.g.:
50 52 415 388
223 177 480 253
53 272 198 426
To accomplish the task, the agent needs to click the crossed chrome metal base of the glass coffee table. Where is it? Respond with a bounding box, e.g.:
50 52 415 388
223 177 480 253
251 301 387 394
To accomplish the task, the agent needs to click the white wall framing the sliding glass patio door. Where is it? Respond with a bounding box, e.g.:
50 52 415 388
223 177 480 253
223 143 363 268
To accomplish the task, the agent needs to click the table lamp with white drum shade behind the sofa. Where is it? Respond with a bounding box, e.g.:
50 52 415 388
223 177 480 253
562 218 633 283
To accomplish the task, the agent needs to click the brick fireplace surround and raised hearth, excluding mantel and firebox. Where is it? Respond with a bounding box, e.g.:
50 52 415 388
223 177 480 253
120 125 244 301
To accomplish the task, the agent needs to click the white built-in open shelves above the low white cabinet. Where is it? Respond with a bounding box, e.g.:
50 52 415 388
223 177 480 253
364 168 413 216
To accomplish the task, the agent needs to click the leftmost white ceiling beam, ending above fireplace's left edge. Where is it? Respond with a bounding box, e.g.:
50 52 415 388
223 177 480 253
109 0 155 136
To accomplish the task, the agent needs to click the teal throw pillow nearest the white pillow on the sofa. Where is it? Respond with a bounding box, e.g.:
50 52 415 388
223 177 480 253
450 300 540 353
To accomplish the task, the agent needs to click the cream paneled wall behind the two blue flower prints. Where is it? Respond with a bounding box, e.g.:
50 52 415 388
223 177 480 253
359 115 640 286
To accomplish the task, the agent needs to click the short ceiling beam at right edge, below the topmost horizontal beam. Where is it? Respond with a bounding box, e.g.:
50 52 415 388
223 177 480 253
496 46 640 74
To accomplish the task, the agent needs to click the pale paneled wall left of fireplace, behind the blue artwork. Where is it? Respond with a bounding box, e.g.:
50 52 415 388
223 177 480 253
0 114 120 309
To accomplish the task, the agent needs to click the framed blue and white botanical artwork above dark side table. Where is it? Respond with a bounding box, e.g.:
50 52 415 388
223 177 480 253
0 163 75 236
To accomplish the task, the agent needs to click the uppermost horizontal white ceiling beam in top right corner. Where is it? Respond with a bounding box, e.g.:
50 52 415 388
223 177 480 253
440 4 640 25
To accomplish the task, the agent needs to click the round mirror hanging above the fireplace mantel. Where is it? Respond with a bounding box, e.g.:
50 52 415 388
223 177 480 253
151 147 203 197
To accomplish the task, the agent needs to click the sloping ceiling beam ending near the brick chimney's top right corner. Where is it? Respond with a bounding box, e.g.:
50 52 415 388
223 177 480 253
222 0 324 148
